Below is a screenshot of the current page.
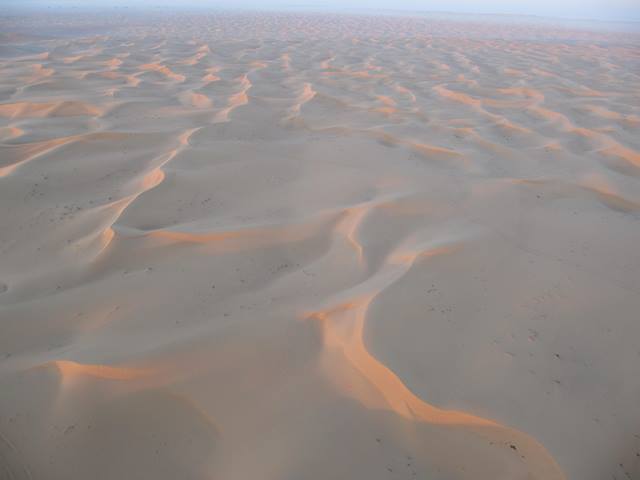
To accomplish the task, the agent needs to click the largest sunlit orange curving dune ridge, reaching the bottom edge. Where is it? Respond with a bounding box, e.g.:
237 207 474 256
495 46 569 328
302 244 565 480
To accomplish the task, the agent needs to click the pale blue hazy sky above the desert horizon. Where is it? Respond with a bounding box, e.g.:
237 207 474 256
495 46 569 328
7 0 640 21
